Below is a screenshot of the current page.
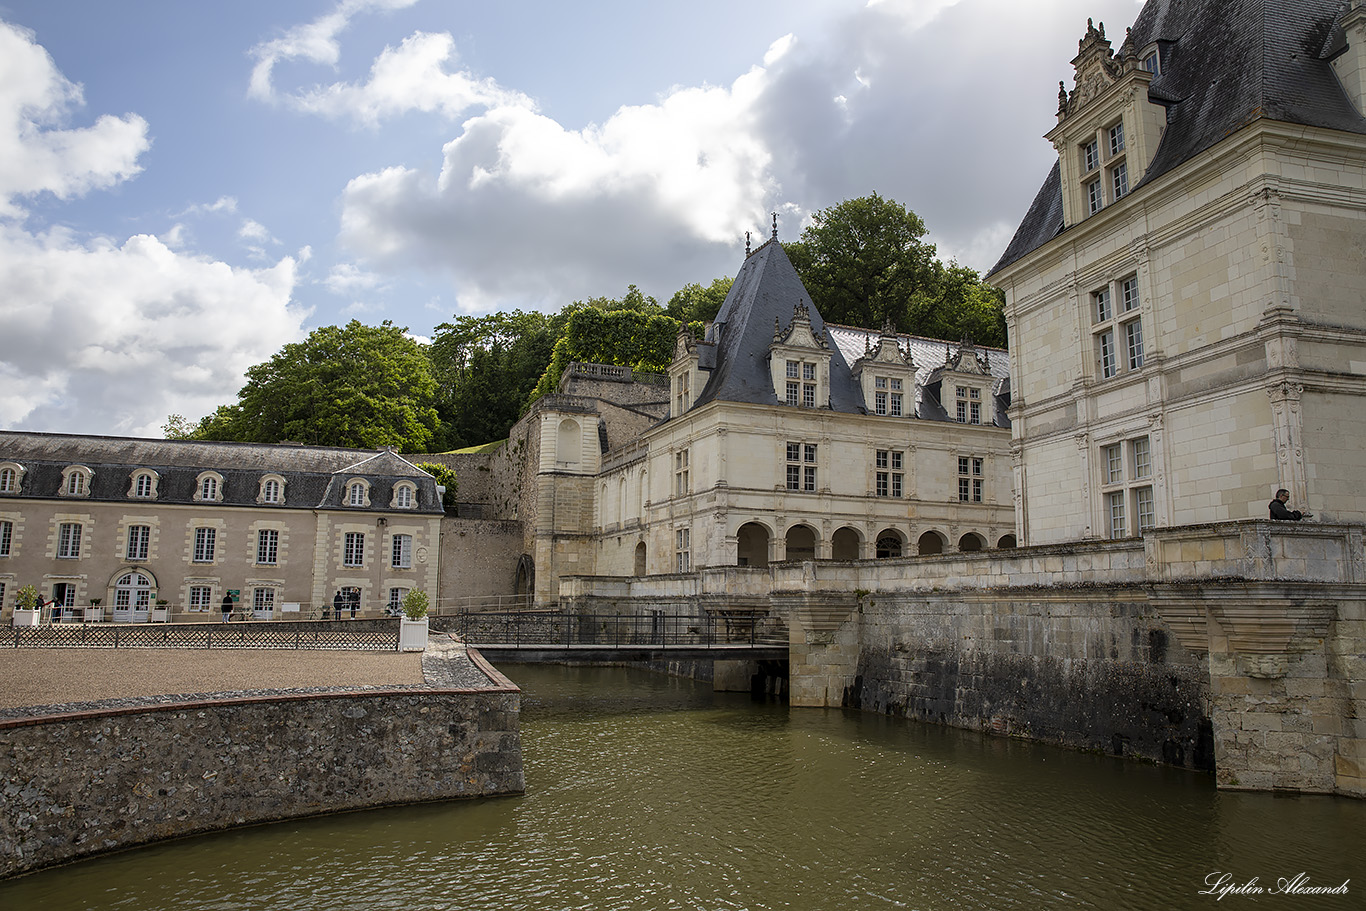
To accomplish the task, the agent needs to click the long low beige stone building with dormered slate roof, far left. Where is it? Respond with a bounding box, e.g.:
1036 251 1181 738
0 432 444 621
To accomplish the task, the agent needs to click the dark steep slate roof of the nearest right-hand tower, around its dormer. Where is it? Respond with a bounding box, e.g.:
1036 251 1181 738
988 0 1366 276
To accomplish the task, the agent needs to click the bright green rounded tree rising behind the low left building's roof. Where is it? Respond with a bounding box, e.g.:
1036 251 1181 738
195 320 437 452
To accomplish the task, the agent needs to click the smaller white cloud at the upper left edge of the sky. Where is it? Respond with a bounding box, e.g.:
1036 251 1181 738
0 22 150 217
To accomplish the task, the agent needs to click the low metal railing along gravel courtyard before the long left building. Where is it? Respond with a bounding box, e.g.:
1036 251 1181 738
0 623 399 651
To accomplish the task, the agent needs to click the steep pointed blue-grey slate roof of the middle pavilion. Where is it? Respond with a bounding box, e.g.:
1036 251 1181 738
694 239 863 414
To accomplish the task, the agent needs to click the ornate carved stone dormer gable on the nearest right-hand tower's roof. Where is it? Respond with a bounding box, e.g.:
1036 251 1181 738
1048 19 1167 225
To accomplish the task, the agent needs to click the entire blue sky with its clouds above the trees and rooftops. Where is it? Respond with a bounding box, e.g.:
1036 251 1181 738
0 0 1141 436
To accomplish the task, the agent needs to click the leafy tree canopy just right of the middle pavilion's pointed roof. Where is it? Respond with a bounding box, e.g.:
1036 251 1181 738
783 193 1005 347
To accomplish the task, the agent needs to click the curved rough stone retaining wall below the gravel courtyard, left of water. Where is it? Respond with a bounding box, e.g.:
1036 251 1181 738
0 647 525 877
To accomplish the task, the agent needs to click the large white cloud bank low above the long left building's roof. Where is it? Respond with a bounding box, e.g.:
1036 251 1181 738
0 228 306 436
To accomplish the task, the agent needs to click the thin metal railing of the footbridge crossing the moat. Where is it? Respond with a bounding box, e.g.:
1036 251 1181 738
458 611 787 647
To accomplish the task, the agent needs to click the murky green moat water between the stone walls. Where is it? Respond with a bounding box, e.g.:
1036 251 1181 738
0 667 1366 911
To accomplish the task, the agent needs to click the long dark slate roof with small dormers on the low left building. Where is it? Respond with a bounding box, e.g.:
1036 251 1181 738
0 430 444 515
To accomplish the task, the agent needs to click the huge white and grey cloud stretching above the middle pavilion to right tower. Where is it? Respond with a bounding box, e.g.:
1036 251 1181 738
333 0 1138 311
